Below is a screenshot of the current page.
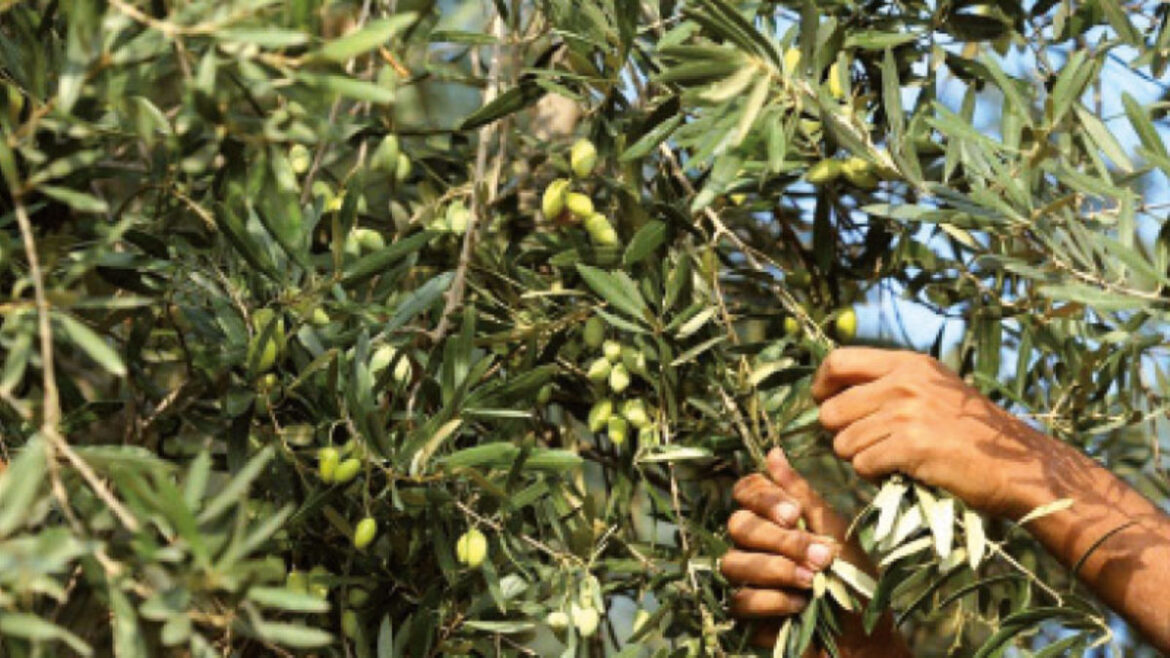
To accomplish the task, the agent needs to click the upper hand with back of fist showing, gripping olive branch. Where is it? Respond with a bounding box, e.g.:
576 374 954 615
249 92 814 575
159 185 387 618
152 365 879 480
812 348 1061 518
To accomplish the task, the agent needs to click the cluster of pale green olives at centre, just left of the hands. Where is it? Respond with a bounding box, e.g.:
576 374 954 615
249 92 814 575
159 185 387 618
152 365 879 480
583 316 658 447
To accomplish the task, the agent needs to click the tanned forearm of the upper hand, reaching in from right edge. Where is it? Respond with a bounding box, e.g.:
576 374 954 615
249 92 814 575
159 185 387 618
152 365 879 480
1010 429 1170 651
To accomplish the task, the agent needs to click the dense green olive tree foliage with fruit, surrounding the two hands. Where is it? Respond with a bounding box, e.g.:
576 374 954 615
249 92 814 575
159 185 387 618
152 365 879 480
0 0 1170 657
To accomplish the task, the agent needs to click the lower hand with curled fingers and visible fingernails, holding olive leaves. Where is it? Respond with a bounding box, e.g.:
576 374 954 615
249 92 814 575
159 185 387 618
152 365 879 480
722 448 910 658
